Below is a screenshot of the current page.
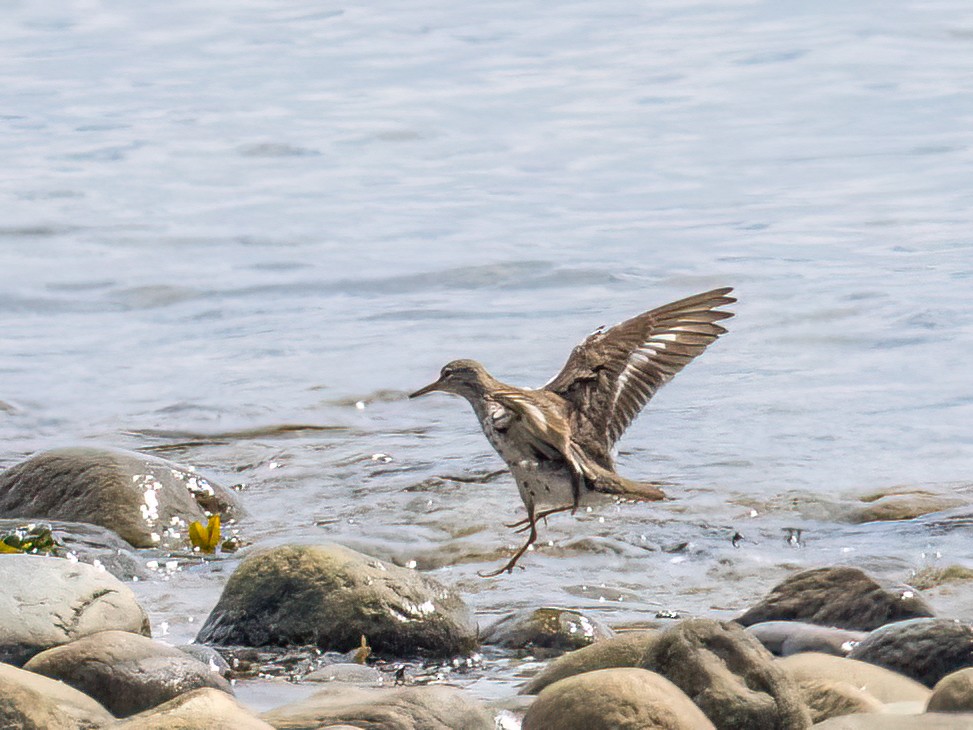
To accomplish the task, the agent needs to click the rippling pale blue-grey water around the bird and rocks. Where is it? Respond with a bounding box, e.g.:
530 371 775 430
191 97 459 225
0 0 973 706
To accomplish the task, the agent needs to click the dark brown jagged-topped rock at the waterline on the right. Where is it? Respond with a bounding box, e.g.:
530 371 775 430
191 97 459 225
737 567 934 631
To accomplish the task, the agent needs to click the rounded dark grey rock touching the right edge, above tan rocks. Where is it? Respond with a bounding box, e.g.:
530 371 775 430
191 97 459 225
848 618 973 687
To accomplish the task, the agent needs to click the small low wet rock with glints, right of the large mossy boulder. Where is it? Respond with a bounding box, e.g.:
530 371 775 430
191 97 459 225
480 608 615 653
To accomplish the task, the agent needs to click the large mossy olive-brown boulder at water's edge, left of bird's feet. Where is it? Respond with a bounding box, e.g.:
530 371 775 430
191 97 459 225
196 544 476 657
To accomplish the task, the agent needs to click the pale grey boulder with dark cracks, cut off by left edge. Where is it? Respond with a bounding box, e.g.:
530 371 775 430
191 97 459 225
0 554 149 666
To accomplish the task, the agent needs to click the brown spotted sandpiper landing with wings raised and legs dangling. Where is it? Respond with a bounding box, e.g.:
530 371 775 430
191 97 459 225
409 287 736 578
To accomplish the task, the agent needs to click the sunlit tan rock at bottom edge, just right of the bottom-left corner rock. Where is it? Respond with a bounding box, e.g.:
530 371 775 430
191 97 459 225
111 688 274 730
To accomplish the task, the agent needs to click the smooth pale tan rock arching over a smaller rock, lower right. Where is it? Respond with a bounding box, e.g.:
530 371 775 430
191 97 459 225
776 653 929 703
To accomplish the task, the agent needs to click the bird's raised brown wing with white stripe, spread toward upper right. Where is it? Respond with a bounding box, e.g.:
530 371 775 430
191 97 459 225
544 287 736 466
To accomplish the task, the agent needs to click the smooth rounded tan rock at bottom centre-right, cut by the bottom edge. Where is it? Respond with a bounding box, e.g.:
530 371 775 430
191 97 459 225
522 667 713 730
